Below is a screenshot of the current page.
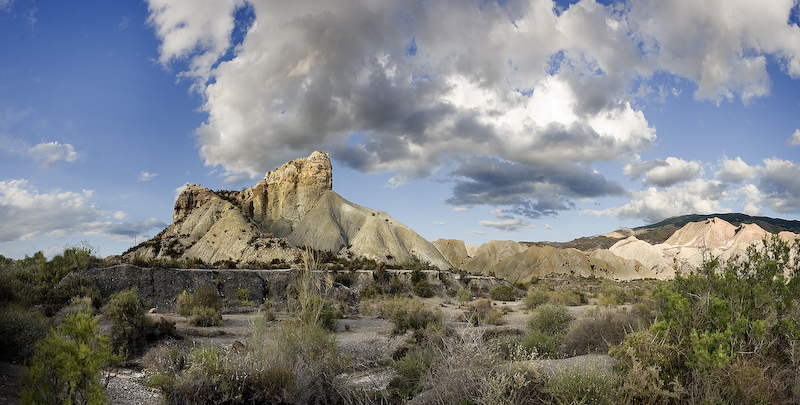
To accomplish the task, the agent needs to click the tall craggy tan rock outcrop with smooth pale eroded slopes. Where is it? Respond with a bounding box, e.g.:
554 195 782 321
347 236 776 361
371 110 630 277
125 152 452 269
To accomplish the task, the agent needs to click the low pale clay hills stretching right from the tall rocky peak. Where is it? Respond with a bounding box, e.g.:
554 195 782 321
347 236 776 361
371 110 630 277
434 218 798 282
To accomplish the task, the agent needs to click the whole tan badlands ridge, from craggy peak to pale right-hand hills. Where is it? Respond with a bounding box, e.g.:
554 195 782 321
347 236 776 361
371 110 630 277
123 152 798 282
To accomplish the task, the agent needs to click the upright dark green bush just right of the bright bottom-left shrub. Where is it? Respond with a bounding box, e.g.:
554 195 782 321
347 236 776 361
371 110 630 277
105 288 153 356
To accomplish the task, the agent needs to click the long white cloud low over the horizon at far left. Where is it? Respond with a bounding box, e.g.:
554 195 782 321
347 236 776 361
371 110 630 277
0 179 166 242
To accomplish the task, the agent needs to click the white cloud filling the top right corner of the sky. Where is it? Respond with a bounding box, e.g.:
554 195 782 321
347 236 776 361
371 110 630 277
628 0 800 102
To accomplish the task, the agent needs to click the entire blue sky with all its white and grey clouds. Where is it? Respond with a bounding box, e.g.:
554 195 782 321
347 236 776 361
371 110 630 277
0 0 800 258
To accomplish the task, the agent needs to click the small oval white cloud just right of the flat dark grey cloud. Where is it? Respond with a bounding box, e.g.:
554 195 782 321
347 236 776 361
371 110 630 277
623 157 703 188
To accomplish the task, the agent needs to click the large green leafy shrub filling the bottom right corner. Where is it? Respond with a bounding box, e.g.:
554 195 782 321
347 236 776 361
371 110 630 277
610 238 800 403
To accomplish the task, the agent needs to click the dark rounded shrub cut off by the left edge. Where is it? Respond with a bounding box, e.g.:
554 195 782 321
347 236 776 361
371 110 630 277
0 305 49 362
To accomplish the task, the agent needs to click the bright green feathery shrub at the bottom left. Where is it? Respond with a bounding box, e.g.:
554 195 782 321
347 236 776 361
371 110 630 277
20 312 118 404
